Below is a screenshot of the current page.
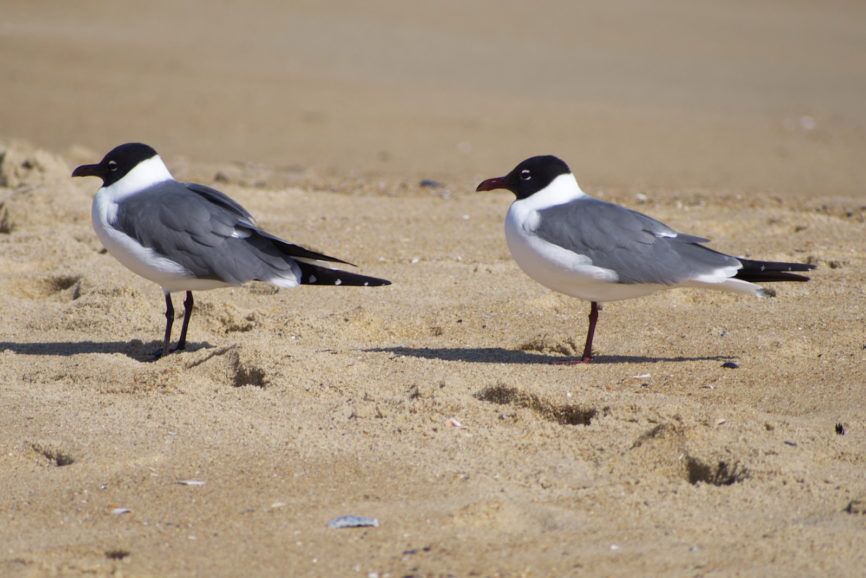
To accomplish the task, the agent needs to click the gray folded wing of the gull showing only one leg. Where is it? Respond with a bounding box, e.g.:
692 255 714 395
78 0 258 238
534 197 740 285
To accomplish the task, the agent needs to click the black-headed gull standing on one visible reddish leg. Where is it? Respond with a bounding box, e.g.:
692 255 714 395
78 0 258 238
477 156 815 363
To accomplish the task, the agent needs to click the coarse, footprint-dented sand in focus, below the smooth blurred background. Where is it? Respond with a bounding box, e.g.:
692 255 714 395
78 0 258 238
0 140 866 575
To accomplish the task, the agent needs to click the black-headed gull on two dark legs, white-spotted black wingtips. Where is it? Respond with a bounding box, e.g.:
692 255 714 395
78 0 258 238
72 143 391 356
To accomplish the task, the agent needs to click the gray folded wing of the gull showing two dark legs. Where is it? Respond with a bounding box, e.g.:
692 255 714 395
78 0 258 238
111 181 299 285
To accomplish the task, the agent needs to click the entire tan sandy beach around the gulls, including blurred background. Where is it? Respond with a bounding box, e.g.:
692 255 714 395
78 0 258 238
0 2 866 578
